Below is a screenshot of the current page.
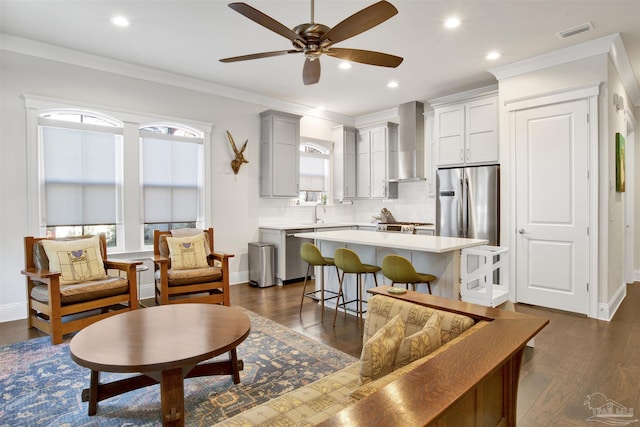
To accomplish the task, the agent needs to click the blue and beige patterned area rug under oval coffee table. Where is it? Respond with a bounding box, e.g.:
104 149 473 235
0 306 356 427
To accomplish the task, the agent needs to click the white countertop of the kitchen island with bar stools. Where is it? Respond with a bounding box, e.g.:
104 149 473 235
294 230 489 253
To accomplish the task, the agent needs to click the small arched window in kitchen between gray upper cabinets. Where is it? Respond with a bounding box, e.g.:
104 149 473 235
299 141 331 203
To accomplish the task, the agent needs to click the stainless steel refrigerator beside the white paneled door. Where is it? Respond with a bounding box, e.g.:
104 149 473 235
436 165 500 246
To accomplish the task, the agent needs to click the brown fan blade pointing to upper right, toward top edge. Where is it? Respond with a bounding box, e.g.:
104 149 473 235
319 0 398 44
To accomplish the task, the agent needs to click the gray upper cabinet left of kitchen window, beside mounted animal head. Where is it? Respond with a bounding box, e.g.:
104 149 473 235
260 110 302 197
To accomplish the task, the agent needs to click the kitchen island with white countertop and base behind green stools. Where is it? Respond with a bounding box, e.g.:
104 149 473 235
294 230 488 301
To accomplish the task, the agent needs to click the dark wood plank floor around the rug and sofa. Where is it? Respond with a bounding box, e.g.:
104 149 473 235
5 283 640 427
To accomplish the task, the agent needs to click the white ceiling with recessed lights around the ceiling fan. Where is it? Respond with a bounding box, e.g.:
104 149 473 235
0 0 640 117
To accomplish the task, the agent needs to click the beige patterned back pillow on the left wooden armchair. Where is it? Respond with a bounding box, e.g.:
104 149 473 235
42 236 106 285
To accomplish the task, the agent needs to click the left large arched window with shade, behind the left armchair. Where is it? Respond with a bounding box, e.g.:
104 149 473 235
38 109 123 246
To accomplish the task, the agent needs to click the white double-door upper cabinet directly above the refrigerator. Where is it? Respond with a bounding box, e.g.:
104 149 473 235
434 88 498 166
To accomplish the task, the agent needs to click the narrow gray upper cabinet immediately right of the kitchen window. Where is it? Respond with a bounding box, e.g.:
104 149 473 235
331 126 356 200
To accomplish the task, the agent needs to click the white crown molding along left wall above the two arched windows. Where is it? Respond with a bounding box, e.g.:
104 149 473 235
0 33 355 126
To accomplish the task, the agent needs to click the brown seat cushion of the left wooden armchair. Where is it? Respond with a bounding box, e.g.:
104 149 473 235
31 277 129 305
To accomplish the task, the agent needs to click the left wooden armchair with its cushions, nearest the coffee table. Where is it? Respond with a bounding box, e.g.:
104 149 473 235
22 233 141 344
